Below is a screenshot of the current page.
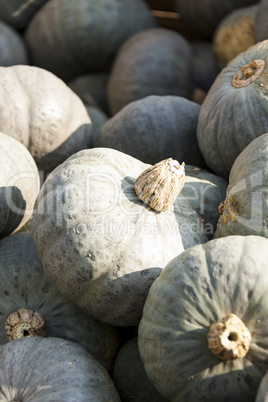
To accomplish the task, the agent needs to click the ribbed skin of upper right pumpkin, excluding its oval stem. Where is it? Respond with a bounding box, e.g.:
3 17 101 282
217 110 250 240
197 41 268 179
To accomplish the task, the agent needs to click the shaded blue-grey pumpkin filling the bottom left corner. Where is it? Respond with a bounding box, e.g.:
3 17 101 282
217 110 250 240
0 337 120 402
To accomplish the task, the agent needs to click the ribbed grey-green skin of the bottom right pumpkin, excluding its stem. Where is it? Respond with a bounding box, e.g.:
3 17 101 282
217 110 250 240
138 236 268 402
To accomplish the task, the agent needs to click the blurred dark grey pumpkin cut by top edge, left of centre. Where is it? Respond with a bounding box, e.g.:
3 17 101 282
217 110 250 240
25 0 156 81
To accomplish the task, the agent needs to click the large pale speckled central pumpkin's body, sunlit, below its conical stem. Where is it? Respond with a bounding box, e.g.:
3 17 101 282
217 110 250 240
32 148 207 326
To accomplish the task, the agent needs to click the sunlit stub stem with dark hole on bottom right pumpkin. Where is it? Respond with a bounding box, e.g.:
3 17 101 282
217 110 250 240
207 314 251 360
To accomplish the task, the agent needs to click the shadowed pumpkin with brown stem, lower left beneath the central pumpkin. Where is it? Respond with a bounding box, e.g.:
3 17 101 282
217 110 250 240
0 233 120 370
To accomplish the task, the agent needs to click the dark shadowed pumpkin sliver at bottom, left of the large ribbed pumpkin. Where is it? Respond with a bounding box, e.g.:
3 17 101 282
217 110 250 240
112 337 167 402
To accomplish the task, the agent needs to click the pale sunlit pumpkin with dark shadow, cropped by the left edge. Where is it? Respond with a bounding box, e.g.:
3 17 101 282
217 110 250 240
0 132 40 238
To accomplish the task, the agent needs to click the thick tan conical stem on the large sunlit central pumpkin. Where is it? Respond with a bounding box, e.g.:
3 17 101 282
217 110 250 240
135 158 185 212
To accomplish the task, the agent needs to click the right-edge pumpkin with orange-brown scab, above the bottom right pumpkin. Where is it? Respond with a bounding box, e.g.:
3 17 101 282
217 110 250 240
214 133 268 238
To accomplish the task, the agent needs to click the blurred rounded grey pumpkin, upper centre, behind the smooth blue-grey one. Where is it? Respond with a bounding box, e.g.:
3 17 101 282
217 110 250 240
107 28 193 115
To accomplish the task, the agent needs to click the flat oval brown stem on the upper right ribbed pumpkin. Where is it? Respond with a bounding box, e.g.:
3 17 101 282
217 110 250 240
232 59 265 88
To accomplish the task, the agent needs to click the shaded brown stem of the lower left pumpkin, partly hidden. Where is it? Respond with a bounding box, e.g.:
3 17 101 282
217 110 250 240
5 308 45 341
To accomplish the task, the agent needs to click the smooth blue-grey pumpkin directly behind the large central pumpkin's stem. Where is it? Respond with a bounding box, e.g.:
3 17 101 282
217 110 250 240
94 95 205 166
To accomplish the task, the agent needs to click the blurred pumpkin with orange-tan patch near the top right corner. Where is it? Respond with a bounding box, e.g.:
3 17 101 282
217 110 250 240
212 4 258 69
